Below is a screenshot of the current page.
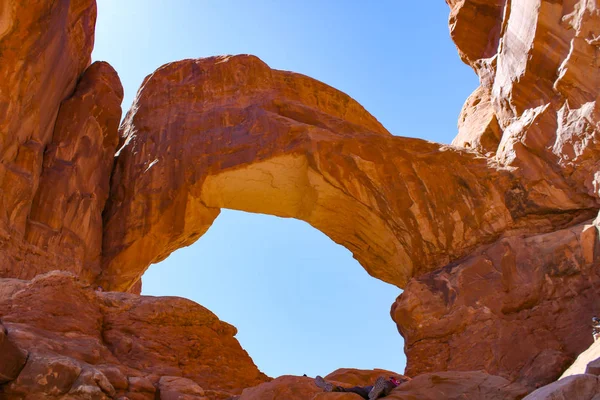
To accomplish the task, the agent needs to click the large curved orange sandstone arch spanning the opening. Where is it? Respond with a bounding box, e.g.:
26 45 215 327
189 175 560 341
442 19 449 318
100 55 592 290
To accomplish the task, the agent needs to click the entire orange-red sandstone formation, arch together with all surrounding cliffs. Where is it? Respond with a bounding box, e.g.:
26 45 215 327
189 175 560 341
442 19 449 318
0 0 600 400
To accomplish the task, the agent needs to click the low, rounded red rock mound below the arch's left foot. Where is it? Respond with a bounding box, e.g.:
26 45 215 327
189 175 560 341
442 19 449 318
0 272 267 399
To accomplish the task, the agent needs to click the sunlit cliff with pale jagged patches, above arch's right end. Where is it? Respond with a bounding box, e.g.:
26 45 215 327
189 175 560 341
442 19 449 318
447 0 600 208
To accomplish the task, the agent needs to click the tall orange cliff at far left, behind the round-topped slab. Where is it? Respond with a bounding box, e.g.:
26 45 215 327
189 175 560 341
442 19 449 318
0 0 99 278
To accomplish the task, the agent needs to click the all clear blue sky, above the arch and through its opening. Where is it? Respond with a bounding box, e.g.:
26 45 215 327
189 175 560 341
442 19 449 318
93 0 477 376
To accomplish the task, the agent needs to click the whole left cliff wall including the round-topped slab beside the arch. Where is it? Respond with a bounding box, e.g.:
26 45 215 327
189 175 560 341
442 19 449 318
0 0 123 279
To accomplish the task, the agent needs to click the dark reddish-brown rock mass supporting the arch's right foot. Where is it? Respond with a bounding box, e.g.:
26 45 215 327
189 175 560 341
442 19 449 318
392 216 600 387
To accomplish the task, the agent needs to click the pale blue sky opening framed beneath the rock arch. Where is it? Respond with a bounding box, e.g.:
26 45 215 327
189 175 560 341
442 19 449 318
142 209 406 376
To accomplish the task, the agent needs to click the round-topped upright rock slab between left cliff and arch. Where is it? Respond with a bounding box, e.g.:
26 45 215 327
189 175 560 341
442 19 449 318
25 62 123 281
